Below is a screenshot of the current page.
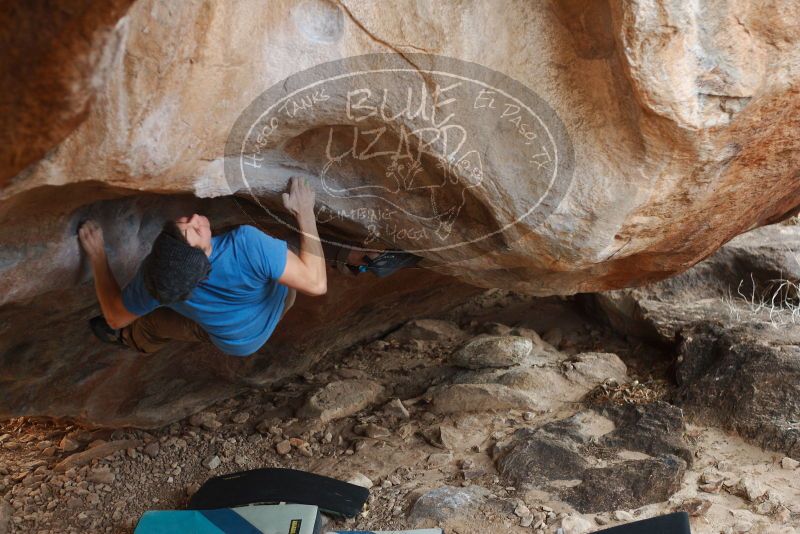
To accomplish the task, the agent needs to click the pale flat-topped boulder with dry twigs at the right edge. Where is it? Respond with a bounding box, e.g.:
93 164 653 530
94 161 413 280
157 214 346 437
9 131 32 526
591 224 800 344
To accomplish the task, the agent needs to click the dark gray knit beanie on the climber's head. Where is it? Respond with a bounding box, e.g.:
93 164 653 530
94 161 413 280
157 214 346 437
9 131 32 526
142 221 211 304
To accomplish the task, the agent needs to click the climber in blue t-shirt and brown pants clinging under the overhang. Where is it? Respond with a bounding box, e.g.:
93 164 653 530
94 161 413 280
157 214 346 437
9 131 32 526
78 177 420 356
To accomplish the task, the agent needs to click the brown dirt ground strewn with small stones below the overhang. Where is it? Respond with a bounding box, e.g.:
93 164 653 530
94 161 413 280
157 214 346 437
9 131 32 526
0 290 800 534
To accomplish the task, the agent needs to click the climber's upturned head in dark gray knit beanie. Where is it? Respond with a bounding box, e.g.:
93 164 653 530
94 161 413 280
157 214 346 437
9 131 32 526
142 213 211 304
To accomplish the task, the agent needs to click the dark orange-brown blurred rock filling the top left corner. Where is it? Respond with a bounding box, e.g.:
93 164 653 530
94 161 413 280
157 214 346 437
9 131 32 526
0 0 133 187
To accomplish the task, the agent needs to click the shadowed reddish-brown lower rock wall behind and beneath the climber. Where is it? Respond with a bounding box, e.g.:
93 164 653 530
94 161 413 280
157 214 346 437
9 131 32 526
0 196 481 427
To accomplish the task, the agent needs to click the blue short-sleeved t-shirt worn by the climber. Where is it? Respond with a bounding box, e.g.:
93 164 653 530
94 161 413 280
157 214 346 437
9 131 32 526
122 225 288 356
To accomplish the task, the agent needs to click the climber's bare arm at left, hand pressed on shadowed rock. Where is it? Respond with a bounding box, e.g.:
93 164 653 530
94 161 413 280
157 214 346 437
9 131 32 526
78 220 138 329
